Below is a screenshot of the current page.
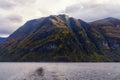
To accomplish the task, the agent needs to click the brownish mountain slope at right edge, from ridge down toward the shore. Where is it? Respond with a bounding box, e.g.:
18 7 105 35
90 17 120 61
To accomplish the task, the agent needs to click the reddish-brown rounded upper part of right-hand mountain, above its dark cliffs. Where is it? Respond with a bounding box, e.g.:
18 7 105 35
90 17 120 38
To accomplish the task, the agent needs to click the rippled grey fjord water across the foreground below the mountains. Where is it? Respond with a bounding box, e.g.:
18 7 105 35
0 63 120 80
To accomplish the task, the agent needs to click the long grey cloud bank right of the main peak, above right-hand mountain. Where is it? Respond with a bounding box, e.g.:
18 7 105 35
63 2 120 21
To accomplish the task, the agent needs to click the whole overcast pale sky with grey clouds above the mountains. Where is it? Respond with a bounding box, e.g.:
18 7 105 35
0 0 120 37
